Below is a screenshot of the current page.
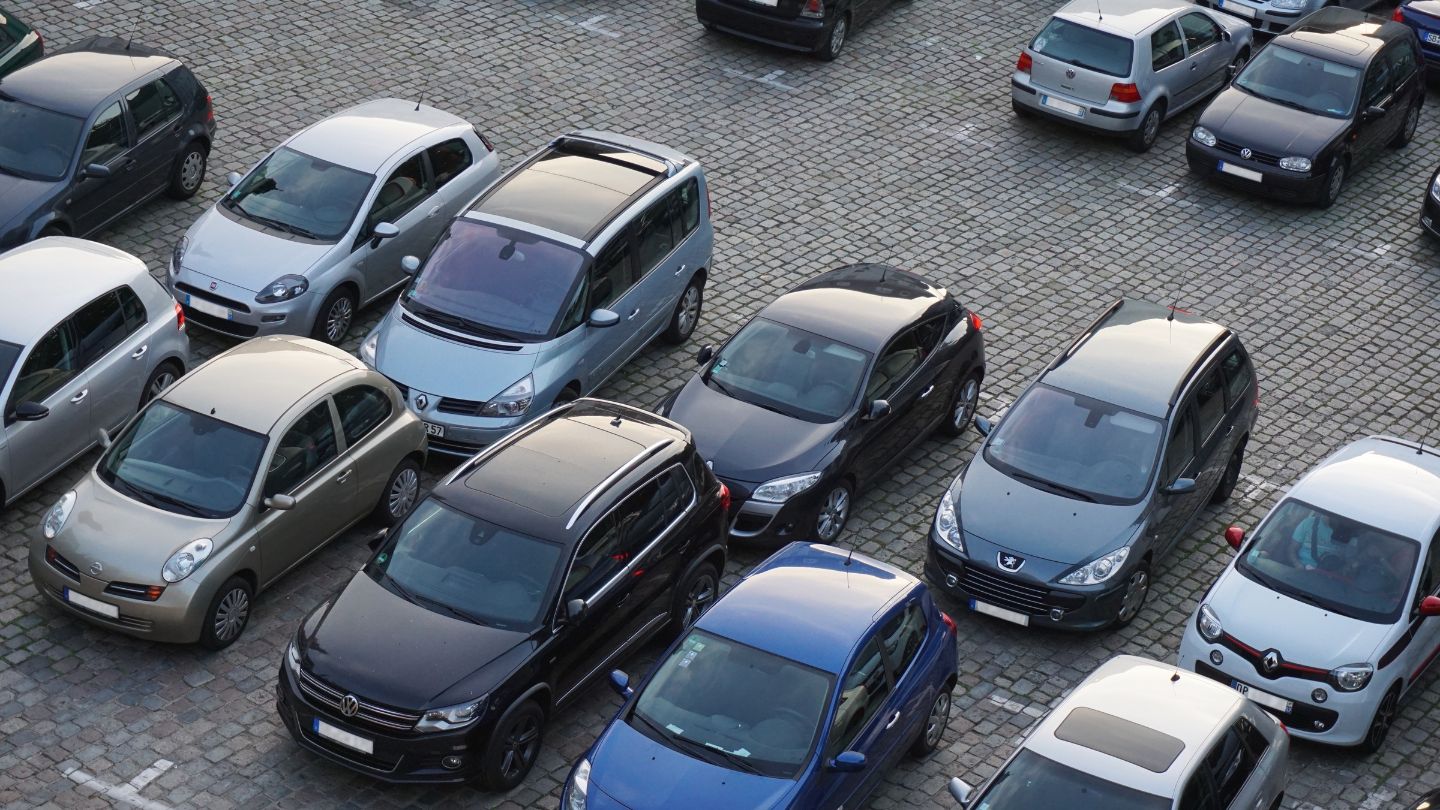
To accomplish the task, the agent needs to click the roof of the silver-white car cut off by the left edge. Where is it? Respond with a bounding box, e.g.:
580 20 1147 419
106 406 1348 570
0 236 150 343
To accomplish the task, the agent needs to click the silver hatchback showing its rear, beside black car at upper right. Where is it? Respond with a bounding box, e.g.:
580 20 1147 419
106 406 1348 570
1009 0 1251 151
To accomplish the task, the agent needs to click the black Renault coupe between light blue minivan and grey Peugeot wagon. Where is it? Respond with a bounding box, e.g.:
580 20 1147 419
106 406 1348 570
660 264 985 543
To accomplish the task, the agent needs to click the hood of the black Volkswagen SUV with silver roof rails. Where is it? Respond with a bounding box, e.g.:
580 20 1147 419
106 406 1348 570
302 571 528 709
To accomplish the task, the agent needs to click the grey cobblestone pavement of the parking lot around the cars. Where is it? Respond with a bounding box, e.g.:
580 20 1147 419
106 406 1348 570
0 0 1440 810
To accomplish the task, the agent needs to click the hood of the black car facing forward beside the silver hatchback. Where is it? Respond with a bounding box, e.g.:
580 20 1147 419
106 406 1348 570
1195 86 1351 157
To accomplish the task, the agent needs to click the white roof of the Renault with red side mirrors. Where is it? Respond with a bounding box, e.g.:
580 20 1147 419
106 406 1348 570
1286 435 1440 543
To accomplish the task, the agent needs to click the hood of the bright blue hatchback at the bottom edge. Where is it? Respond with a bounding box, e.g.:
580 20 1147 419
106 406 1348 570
590 718 795 810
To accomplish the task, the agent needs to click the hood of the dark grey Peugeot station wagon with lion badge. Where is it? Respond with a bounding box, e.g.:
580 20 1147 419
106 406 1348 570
958 453 1145 565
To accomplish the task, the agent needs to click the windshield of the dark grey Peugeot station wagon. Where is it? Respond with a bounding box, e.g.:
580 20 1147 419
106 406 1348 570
985 385 1164 503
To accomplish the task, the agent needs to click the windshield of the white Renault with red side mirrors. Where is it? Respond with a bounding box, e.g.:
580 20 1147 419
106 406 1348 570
1236 499 1420 624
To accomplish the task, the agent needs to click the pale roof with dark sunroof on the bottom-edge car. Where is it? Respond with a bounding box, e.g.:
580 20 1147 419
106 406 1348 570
1024 656 1244 797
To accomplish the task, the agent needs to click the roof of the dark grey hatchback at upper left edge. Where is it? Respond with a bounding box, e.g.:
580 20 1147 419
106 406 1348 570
0 36 176 118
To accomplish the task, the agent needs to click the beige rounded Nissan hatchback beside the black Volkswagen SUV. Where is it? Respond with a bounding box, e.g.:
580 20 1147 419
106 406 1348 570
30 337 425 650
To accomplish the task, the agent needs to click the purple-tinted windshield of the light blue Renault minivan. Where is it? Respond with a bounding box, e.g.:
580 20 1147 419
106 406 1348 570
400 219 585 340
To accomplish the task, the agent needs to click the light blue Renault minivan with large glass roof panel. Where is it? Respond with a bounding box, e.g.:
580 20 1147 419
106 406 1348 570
360 131 714 455
